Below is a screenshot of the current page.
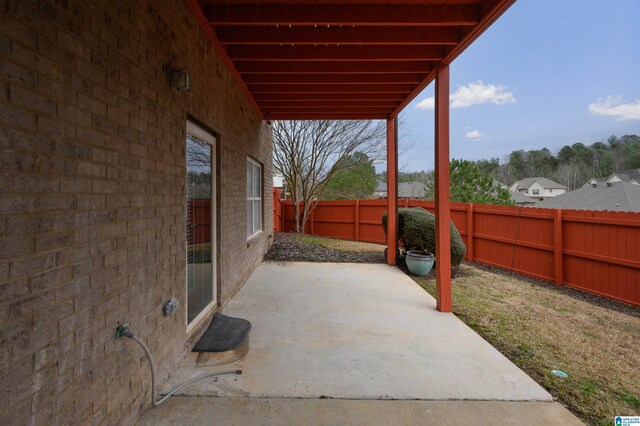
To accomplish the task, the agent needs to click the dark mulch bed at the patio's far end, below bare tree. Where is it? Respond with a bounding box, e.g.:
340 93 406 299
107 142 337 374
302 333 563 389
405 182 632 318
264 232 385 263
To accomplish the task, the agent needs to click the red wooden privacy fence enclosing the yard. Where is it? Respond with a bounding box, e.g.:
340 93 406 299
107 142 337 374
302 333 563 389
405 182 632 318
274 197 640 305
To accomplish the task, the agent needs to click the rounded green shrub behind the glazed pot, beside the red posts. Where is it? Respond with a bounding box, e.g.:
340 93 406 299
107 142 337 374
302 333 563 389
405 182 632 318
382 207 467 266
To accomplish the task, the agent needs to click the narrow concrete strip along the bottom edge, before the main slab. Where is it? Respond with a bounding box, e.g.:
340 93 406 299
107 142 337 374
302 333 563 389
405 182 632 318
138 397 582 426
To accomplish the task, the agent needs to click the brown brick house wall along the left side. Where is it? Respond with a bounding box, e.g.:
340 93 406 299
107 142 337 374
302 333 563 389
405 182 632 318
0 0 272 424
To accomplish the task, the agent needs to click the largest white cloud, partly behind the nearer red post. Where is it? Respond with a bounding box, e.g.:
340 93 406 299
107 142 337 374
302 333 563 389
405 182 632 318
416 80 516 109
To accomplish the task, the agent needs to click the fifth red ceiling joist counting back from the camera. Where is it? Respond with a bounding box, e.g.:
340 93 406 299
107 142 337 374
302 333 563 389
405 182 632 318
243 74 424 84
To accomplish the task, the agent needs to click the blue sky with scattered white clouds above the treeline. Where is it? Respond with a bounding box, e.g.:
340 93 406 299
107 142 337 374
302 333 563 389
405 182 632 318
396 0 640 171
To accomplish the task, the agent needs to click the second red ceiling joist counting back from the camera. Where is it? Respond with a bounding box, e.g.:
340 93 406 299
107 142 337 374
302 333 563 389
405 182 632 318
217 26 461 46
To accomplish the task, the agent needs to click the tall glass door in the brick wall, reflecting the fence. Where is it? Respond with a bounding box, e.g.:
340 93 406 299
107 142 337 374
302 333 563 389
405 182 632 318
186 122 216 325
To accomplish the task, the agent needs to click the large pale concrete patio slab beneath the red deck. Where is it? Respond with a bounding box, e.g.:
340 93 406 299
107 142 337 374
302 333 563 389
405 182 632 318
166 263 552 401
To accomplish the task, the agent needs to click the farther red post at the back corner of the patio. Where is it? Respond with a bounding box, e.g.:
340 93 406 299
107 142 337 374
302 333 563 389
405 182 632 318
387 118 398 265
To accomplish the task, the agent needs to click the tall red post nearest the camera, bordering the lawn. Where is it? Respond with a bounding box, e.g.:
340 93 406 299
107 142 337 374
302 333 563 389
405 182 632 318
435 65 452 312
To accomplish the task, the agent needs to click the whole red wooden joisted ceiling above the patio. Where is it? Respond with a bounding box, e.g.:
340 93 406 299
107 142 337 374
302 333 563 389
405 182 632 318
186 0 515 120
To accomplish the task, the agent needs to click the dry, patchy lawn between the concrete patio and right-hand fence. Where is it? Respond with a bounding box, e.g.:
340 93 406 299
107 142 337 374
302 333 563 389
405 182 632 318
412 265 640 425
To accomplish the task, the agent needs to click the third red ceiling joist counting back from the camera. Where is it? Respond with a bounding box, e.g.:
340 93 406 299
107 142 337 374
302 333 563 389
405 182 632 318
227 45 445 61
